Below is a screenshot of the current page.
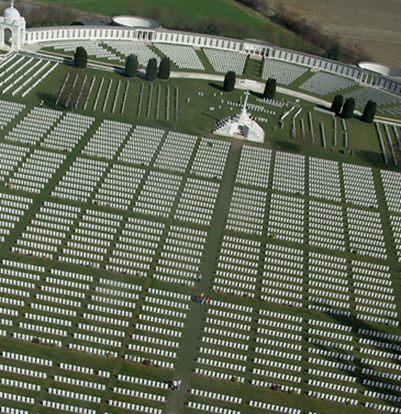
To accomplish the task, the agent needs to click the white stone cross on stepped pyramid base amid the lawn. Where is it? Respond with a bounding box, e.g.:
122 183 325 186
213 91 265 142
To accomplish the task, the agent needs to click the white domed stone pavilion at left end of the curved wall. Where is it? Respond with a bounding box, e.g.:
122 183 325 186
0 0 26 50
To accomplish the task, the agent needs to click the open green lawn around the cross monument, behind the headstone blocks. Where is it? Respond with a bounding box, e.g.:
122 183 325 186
27 59 383 170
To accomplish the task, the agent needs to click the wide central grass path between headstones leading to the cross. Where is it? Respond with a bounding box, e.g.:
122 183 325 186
166 142 242 414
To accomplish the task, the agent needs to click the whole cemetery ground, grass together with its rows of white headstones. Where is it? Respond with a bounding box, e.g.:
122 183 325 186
0 20 401 414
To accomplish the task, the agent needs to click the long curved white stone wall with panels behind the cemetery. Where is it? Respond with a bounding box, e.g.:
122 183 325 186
25 26 401 95
